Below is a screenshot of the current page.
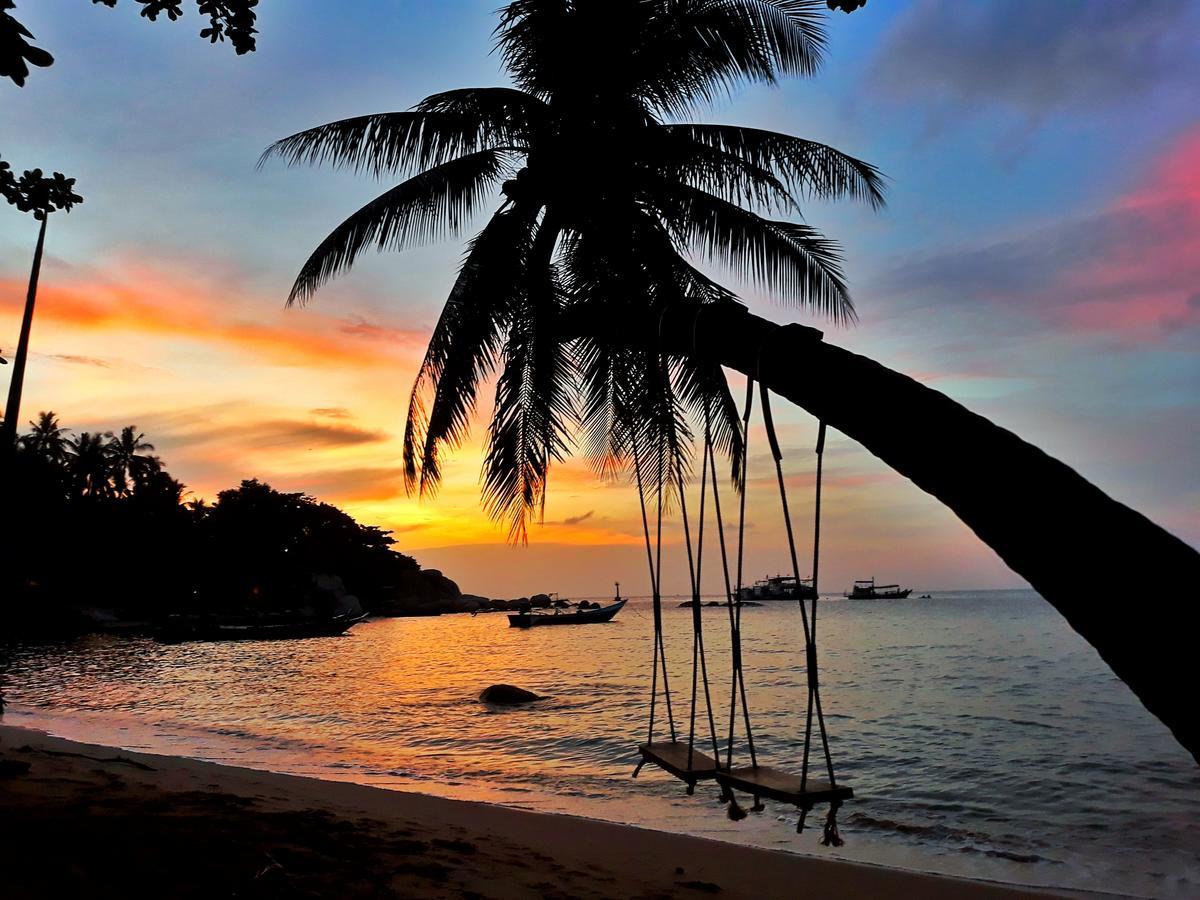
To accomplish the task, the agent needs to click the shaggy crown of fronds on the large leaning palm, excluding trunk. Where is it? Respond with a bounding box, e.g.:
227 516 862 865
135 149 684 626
264 0 883 540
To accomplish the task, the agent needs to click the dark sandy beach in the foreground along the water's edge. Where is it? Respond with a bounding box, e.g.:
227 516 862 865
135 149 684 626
0 725 1094 900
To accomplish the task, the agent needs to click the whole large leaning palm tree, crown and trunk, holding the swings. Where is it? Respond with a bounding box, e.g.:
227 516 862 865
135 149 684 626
264 0 1200 758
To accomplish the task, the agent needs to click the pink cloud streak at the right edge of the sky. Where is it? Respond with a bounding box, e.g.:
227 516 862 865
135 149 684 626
880 127 1200 343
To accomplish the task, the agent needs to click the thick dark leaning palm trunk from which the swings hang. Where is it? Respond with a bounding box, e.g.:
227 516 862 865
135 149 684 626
638 307 1200 762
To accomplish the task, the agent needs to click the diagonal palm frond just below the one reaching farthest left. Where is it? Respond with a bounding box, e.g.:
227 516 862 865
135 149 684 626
288 150 508 305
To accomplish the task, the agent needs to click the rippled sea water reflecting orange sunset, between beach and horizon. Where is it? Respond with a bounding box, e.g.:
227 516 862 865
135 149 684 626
0 592 1200 898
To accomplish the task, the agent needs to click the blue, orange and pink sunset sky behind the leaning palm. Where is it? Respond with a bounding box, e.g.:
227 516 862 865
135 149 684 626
0 0 1200 596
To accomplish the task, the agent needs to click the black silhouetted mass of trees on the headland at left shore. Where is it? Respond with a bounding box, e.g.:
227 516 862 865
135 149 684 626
0 412 424 634
